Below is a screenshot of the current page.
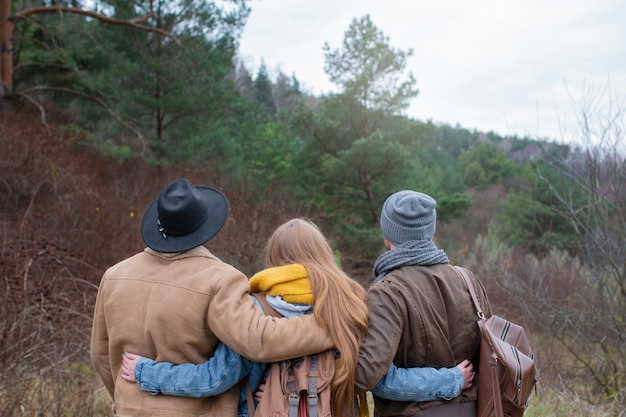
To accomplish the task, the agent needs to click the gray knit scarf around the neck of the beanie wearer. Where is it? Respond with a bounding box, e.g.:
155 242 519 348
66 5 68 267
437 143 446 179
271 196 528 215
372 240 450 284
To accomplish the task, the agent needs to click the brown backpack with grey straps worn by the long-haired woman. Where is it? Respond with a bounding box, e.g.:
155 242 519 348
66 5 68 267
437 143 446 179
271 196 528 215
248 293 335 417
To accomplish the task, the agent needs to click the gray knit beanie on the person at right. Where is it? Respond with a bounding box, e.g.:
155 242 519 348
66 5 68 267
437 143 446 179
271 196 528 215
380 190 437 245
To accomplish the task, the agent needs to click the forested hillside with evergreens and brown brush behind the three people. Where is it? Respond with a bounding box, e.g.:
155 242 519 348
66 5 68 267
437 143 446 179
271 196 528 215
0 0 626 417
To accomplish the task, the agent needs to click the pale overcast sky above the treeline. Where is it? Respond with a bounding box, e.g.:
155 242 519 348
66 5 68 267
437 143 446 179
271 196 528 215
240 0 626 140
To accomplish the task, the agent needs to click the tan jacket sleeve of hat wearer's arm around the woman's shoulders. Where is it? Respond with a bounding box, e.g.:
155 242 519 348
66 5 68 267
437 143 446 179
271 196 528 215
207 269 334 362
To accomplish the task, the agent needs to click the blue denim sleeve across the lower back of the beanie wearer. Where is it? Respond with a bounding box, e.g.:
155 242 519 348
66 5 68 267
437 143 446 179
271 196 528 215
372 364 463 401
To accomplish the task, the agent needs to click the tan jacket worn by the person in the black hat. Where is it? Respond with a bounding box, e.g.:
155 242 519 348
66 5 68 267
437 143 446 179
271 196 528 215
91 247 333 417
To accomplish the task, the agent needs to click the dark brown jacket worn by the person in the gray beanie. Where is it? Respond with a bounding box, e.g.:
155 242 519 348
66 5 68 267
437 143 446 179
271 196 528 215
356 264 491 416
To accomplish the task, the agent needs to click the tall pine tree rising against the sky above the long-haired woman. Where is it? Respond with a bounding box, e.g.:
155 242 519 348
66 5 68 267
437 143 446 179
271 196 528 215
280 16 419 232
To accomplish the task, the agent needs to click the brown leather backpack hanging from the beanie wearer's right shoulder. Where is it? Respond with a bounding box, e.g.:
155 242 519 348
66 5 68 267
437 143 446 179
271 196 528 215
457 267 538 417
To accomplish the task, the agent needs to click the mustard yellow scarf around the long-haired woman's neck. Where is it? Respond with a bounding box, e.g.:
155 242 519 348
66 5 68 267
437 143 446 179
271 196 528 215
250 264 315 304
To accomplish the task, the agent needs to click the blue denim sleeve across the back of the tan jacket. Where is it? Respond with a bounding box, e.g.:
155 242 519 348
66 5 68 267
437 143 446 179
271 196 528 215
135 344 253 398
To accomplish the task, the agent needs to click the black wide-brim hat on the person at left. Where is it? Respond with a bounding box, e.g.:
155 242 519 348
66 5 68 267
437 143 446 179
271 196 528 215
141 179 228 253
